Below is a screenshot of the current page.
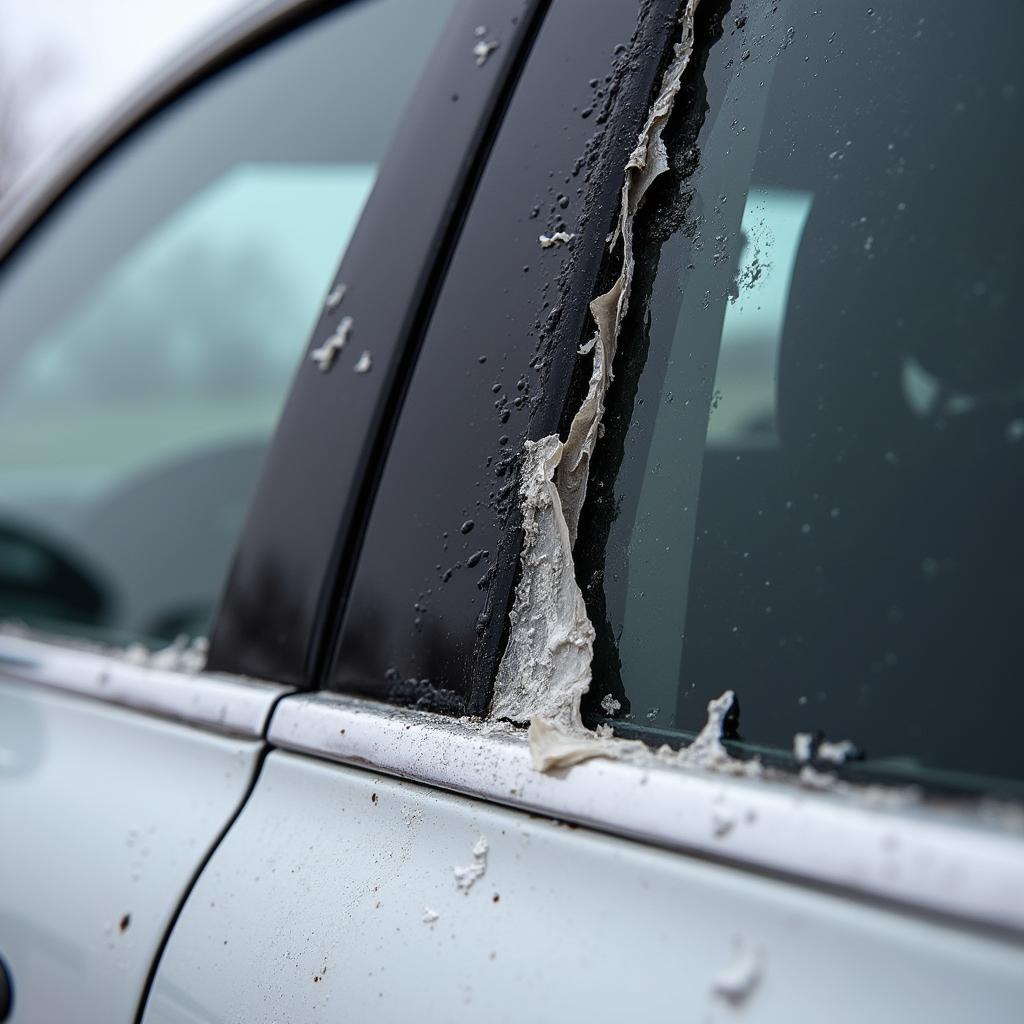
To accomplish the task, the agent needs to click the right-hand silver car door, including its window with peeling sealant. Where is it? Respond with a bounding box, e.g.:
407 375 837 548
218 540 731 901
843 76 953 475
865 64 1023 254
144 0 1024 1022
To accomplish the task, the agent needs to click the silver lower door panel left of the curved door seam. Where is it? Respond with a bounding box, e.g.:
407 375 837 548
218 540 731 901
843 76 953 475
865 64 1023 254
0 677 261 1022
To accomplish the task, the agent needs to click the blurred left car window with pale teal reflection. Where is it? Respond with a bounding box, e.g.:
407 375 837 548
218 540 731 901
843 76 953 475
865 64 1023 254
0 0 451 642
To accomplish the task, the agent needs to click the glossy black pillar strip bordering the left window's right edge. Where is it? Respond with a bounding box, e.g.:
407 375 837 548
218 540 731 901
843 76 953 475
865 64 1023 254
210 0 547 686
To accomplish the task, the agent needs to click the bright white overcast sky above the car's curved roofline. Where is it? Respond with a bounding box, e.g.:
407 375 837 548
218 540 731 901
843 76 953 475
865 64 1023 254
0 0 253 172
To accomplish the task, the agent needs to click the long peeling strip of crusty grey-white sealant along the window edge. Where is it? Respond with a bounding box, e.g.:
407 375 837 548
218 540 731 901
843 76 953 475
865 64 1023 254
490 0 697 745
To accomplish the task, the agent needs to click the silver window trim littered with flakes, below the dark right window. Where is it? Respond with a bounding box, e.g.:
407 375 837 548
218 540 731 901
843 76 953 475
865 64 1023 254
268 693 1024 936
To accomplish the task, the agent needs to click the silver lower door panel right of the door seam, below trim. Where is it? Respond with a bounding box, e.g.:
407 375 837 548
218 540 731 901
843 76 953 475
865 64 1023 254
144 736 1024 1024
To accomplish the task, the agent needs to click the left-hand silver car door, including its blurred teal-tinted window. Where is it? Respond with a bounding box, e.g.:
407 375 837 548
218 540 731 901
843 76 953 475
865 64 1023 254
0 0 460 1021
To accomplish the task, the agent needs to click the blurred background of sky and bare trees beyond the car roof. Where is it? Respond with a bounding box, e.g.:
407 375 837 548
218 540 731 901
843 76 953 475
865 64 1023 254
0 0 248 208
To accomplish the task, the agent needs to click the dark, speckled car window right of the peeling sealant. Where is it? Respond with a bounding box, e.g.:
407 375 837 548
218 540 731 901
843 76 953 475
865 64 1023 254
575 0 1024 786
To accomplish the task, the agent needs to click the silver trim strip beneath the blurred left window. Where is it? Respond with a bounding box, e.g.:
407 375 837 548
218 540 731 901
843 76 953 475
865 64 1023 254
0 633 292 737
